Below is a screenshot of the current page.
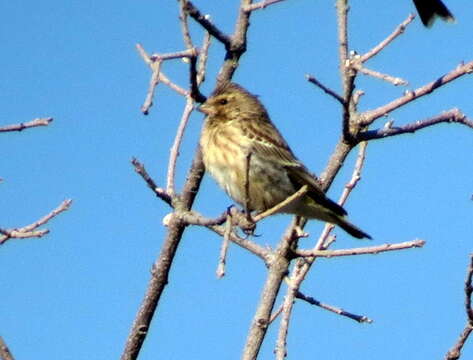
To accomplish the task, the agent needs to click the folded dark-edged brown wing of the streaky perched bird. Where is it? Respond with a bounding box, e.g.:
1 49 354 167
243 117 347 216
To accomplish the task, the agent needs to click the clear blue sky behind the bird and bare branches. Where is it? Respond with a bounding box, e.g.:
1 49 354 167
0 0 473 360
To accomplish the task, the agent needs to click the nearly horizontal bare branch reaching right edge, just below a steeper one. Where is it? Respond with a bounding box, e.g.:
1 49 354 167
358 109 473 141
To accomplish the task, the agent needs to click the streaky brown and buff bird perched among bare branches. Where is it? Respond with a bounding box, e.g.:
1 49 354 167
199 82 371 239
